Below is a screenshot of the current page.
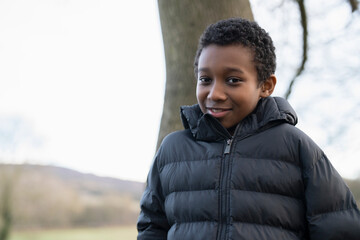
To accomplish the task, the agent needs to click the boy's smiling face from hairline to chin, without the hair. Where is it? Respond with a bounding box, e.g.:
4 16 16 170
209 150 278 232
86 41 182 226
196 44 264 131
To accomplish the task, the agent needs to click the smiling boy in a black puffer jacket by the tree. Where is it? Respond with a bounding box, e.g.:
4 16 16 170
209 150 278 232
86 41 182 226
138 18 360 240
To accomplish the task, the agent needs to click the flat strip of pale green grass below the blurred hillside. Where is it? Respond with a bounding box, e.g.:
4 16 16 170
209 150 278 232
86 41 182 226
9 226 137 240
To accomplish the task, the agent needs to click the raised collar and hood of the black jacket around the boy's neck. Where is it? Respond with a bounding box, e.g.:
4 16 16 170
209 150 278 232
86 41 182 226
181 97 298 141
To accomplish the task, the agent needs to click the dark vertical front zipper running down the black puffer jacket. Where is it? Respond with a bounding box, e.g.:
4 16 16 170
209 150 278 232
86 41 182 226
217 137 233 240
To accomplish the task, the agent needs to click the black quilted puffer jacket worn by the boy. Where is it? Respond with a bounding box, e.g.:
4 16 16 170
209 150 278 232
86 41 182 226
138 97 360 240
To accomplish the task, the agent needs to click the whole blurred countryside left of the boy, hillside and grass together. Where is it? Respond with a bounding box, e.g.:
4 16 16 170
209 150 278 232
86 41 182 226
0 164 144 240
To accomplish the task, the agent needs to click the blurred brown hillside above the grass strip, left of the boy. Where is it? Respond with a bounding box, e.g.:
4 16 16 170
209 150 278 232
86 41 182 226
0 164 144 228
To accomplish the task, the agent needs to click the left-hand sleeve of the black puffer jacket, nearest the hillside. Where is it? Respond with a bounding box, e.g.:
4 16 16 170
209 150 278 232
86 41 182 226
137 154 170 240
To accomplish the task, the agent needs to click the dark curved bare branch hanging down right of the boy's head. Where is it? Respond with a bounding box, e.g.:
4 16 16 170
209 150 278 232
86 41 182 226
285 0 308 99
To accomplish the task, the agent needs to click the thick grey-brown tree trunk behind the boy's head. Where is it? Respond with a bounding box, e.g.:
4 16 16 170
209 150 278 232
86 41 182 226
157 0 253 147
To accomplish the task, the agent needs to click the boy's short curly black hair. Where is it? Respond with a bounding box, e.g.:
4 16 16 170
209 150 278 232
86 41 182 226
194 18 276 84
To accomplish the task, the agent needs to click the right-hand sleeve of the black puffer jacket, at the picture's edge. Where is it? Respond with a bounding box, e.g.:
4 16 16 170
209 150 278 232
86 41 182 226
304 154 360 240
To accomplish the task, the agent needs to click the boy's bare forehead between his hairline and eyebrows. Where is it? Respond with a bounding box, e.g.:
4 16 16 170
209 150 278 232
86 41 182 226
198 44 256 72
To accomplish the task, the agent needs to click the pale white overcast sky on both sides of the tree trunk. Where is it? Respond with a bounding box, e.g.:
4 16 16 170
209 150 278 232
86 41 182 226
0 0 360 181
